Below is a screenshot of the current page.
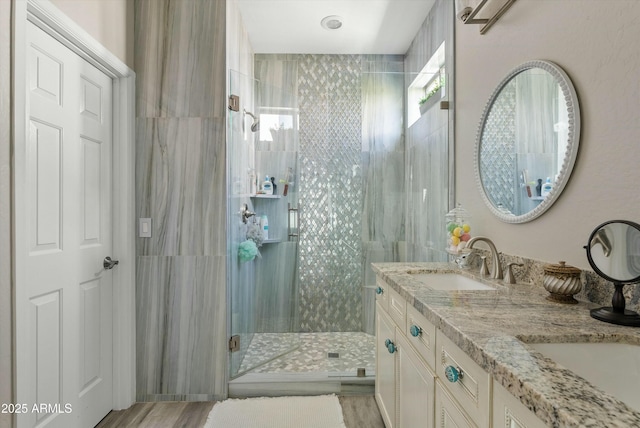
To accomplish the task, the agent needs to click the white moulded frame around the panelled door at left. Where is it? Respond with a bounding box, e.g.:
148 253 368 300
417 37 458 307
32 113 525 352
12 0 136 410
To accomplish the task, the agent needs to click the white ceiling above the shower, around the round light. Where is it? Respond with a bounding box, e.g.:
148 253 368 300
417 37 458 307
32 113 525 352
236 0 435 54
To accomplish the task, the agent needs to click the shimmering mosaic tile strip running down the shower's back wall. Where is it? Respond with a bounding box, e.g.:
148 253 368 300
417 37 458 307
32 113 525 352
298 55 362 332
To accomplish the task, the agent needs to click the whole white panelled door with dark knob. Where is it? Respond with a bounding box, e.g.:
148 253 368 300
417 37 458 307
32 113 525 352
16 23 113 427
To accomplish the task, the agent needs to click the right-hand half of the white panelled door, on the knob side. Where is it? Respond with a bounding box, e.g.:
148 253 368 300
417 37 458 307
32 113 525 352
76 30 113 426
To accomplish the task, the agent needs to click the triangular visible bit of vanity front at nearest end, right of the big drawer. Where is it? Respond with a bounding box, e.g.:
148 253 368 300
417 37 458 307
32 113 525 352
493 381 545 428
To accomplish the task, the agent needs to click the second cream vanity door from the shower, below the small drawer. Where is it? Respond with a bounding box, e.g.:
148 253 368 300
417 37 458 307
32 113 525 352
396 332 435 428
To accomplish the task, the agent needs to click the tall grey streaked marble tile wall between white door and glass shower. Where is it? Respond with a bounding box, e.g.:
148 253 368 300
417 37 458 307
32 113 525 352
134 0 226 401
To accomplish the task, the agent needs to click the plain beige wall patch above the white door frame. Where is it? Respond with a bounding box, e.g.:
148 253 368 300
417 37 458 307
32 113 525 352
51 0 134 69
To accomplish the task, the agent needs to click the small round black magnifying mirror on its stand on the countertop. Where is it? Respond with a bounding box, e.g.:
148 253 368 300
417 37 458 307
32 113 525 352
584 220 640 327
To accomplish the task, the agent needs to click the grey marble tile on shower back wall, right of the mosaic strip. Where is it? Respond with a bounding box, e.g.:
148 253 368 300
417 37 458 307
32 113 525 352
361 55 406 334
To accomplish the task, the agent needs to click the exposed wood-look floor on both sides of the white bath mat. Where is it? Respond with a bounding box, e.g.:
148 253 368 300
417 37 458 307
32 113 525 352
96 395 384 428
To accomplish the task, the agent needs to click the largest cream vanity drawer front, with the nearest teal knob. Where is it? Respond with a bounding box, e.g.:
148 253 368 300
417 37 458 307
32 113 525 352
436 330 491 428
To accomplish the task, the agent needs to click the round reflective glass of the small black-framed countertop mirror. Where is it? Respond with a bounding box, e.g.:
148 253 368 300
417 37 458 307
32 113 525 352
587 221 640 283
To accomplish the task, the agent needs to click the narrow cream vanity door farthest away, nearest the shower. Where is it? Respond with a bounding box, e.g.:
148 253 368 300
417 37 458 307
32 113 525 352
376 303 396 428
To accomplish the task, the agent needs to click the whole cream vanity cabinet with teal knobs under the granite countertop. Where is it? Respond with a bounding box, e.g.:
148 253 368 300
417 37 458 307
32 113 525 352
376 278 545 428
